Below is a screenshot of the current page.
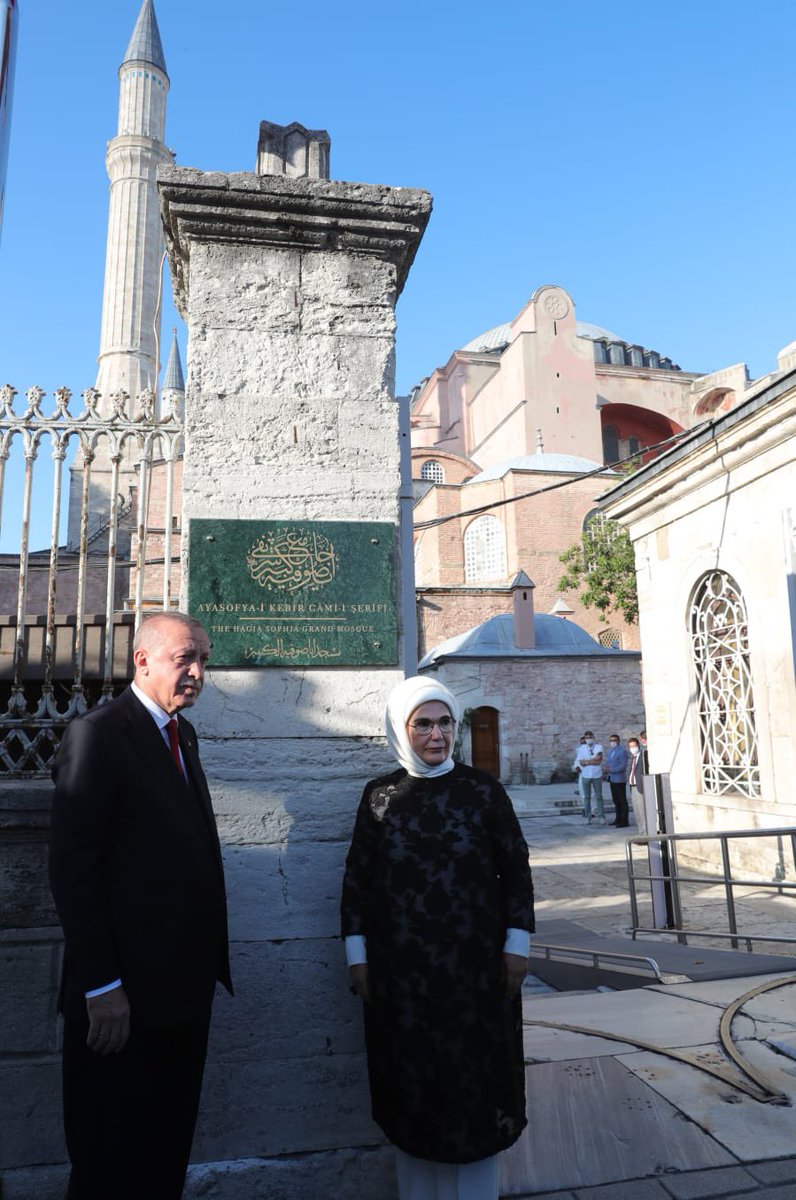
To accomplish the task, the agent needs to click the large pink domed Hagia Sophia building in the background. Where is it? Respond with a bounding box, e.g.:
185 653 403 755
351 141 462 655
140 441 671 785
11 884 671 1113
411 286 748 653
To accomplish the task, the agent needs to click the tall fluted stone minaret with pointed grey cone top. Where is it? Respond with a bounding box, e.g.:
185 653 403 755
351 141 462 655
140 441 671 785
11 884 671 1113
97 0 172 412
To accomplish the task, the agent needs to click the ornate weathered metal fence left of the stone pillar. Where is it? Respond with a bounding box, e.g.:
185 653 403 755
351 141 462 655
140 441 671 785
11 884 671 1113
0 384 182 778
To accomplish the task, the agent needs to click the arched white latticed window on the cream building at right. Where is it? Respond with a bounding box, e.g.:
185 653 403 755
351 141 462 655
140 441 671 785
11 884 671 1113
690 571 760 796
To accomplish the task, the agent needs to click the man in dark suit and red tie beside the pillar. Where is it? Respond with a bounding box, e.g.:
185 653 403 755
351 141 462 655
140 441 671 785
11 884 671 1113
50 612 232 1200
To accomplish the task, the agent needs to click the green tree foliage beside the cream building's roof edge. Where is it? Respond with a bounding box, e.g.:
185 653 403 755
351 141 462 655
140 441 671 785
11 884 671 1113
558 514 639 625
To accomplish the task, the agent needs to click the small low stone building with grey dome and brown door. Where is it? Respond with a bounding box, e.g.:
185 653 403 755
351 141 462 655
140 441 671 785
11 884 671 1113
420 571 644 784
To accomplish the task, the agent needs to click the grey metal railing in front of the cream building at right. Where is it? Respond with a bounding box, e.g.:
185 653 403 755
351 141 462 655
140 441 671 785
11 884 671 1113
626 826 796 953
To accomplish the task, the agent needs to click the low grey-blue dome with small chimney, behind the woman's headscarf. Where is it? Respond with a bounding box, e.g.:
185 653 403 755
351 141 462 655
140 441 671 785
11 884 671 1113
418 613 628 670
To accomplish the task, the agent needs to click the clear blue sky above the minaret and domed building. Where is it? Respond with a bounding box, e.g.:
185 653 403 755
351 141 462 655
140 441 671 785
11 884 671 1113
0 0 796 422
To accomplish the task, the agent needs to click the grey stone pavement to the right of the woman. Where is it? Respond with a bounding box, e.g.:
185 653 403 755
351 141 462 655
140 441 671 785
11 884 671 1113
501 785 796 1200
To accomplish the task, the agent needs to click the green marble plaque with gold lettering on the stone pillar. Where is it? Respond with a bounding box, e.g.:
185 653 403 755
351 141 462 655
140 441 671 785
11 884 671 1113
188 520 397 667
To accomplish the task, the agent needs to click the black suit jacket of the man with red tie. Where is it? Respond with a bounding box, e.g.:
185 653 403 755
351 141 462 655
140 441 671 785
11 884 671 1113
50 688 232 1026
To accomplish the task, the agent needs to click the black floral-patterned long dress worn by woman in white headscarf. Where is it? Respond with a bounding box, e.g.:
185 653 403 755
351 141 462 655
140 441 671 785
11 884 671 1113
342 764 533 1163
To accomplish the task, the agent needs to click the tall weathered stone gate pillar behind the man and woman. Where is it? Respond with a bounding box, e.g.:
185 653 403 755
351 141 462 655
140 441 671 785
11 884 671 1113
158 167 431 1200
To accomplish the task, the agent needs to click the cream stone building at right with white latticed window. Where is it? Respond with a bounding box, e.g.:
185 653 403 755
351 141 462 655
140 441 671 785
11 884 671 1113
603 343 796 878
